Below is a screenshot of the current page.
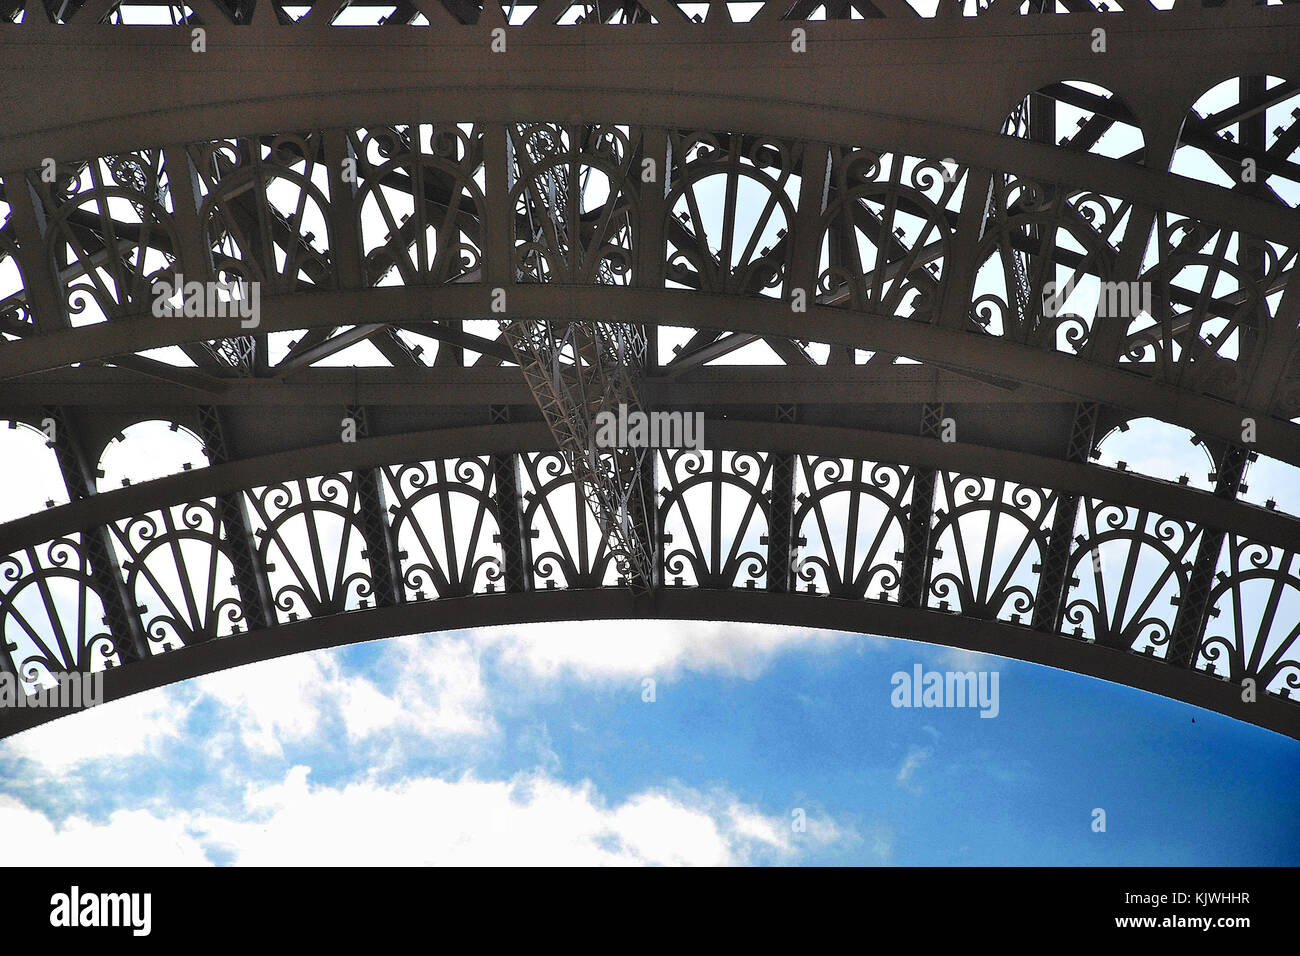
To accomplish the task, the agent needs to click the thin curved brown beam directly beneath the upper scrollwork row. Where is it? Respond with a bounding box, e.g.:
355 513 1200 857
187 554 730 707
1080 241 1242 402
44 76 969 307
0 291 1300 466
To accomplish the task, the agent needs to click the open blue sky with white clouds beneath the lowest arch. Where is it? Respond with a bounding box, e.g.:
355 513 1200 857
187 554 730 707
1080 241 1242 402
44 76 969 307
0 622 1300 865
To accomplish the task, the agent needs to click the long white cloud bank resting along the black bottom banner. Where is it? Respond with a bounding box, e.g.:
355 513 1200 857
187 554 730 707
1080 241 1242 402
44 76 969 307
0 766 858 866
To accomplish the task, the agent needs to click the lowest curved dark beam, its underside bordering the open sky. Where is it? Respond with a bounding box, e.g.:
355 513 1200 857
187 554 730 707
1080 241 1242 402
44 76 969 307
0 588 1300 739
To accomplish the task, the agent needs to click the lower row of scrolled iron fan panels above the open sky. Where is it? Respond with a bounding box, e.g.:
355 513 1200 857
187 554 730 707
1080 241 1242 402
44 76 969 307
0 429 1300 738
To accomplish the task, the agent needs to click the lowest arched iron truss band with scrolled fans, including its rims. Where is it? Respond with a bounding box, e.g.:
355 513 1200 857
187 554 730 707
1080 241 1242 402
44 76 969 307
0 419 1300 736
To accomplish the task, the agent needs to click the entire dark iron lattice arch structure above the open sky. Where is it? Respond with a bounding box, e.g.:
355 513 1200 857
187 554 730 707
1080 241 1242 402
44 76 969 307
0 0 1300 736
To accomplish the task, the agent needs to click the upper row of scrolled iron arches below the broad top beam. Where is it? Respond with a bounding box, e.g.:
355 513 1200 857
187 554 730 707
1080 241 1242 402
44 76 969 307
0 105 1300 419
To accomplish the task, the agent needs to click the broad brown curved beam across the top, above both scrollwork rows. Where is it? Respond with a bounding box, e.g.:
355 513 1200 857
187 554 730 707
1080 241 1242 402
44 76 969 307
0 5 1300 212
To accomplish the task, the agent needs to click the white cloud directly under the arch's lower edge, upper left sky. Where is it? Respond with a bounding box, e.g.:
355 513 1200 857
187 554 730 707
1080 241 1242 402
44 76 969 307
0 620 866 775
